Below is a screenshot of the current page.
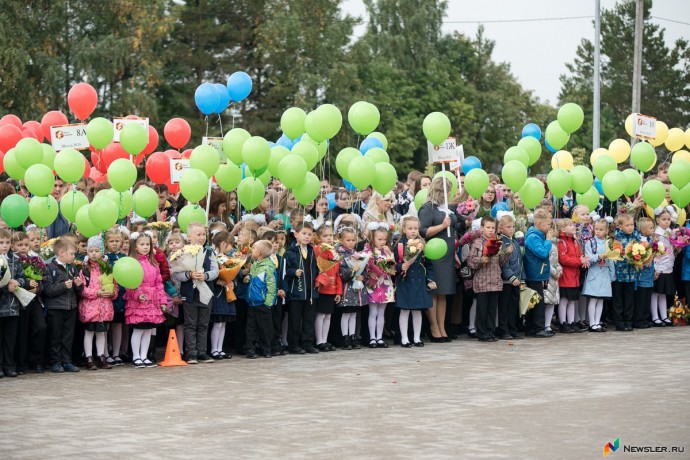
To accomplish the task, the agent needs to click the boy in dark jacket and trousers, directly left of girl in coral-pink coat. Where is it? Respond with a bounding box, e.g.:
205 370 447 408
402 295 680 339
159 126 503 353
43 237 84 373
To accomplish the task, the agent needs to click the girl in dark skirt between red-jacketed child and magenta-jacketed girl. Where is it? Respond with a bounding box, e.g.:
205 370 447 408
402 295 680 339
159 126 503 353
336 225 369 350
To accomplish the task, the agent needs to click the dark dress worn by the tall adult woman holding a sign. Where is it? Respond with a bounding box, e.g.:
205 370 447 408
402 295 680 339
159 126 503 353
419 202 458 295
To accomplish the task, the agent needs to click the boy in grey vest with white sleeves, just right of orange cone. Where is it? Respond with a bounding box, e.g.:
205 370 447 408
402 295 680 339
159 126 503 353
173 222 219 364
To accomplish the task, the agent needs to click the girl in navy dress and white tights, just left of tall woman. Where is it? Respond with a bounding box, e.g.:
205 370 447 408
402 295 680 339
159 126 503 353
393 216 436 348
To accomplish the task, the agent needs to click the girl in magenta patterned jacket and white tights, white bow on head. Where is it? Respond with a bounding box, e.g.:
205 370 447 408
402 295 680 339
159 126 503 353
364 222 395 348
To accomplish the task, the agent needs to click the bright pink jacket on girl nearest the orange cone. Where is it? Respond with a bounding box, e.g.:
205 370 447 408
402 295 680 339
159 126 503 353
125 256 167 324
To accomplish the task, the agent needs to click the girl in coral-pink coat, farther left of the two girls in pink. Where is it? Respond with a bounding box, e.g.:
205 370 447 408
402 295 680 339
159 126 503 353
79 236 118 371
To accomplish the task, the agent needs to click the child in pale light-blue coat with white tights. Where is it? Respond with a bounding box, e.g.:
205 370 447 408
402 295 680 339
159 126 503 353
582 219 612 332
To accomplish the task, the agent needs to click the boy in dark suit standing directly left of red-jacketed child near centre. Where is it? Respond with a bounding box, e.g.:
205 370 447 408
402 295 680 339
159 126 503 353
285 222 319 355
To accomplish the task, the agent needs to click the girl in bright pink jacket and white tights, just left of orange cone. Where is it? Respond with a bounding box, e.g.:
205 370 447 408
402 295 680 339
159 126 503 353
125 232 166 368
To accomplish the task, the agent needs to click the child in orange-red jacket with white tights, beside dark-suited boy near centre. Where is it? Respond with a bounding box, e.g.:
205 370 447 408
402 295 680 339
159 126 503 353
314 224 343 351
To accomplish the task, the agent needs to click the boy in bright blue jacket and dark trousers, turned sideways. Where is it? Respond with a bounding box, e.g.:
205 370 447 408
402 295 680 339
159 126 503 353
524 209 554 338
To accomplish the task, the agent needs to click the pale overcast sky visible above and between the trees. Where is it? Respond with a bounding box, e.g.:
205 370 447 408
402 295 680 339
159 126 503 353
342 0 690 105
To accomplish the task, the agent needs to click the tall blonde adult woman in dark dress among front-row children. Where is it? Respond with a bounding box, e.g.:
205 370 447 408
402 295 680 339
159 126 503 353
419 177 457 342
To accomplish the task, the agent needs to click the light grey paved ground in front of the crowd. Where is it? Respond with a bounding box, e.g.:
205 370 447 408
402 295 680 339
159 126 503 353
0 327 690 459
